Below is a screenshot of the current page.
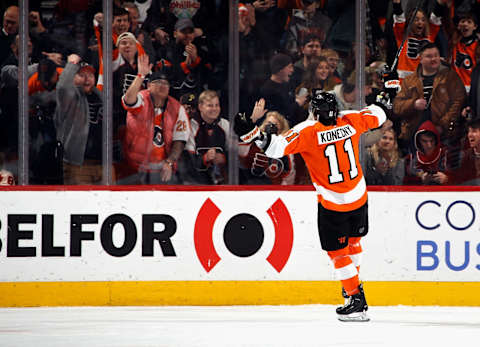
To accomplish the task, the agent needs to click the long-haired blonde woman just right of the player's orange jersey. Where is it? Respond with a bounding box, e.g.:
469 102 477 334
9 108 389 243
364 128 405 185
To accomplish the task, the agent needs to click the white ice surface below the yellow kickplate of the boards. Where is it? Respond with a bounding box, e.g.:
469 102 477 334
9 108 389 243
0 305 480 347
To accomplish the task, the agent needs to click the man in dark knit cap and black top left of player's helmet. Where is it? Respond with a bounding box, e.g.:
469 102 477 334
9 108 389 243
260 53 307 127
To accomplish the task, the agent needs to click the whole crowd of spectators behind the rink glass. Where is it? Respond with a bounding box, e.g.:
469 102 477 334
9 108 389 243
0 0 480 185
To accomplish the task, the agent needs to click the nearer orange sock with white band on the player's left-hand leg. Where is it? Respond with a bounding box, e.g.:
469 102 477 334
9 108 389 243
327 247 360 295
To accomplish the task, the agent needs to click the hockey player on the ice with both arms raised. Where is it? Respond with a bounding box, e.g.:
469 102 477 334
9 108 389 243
234 89 390 321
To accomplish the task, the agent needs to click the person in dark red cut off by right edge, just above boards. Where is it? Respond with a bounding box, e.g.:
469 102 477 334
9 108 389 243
448 118 480 186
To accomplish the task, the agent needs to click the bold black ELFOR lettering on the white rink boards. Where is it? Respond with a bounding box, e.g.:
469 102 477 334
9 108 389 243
0 213 177 257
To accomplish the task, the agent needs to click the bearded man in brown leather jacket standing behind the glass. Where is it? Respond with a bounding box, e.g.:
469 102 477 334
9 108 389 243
393 43 466 157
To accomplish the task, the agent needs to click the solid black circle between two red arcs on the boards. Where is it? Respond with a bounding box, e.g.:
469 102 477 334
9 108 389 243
223 213 264 257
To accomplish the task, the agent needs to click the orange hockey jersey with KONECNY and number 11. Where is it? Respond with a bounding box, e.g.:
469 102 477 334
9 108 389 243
265 105 386 211
